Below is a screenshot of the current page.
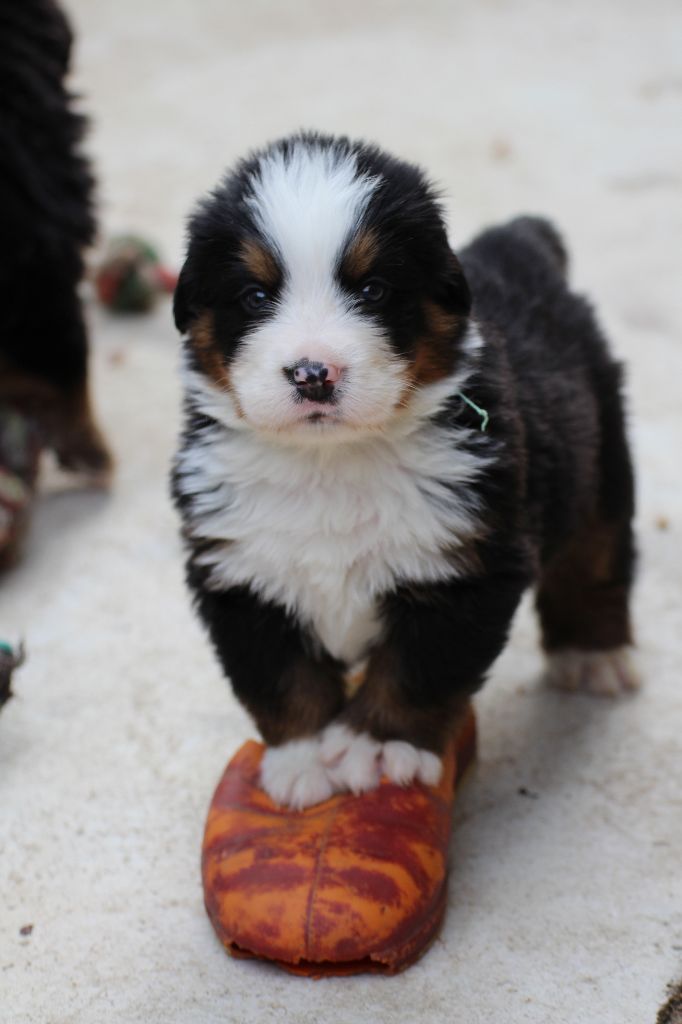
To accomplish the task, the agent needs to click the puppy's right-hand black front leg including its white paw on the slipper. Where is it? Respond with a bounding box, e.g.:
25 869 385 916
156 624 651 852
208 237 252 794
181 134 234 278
322 571 527 793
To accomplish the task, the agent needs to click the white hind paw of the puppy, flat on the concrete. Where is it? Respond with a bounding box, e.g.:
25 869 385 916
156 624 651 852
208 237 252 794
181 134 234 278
545 647 641 697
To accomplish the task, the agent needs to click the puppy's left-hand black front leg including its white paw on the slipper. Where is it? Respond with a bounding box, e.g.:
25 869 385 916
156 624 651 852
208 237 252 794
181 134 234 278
197 587 344 809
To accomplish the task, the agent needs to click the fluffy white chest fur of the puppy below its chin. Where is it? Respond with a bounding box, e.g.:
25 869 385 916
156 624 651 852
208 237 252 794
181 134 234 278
178 380 485 665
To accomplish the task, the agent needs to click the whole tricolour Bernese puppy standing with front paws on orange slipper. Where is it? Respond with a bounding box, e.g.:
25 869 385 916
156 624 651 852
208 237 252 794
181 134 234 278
173 133 637 808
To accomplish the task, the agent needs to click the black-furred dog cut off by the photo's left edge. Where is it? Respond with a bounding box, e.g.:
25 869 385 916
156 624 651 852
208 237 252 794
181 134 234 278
0 0 111 482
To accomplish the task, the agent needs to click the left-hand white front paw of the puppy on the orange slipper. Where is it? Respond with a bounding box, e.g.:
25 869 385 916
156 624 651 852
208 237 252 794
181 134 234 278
260 737 334 811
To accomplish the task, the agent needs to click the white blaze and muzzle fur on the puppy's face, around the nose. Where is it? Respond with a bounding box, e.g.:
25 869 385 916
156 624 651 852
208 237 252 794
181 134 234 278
231 143 406 436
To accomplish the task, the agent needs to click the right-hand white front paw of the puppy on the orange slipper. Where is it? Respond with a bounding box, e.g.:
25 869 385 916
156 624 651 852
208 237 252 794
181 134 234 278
321 725 442 793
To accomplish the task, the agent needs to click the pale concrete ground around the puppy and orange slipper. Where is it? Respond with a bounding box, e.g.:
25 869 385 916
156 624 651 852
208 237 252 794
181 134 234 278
0 0 682 1024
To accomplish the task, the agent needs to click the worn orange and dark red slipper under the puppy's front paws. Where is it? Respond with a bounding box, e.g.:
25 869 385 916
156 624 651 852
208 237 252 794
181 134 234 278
202 711 476 977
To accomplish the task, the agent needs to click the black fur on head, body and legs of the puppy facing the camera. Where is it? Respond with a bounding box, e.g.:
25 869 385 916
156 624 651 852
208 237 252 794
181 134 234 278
169 136 634 752
